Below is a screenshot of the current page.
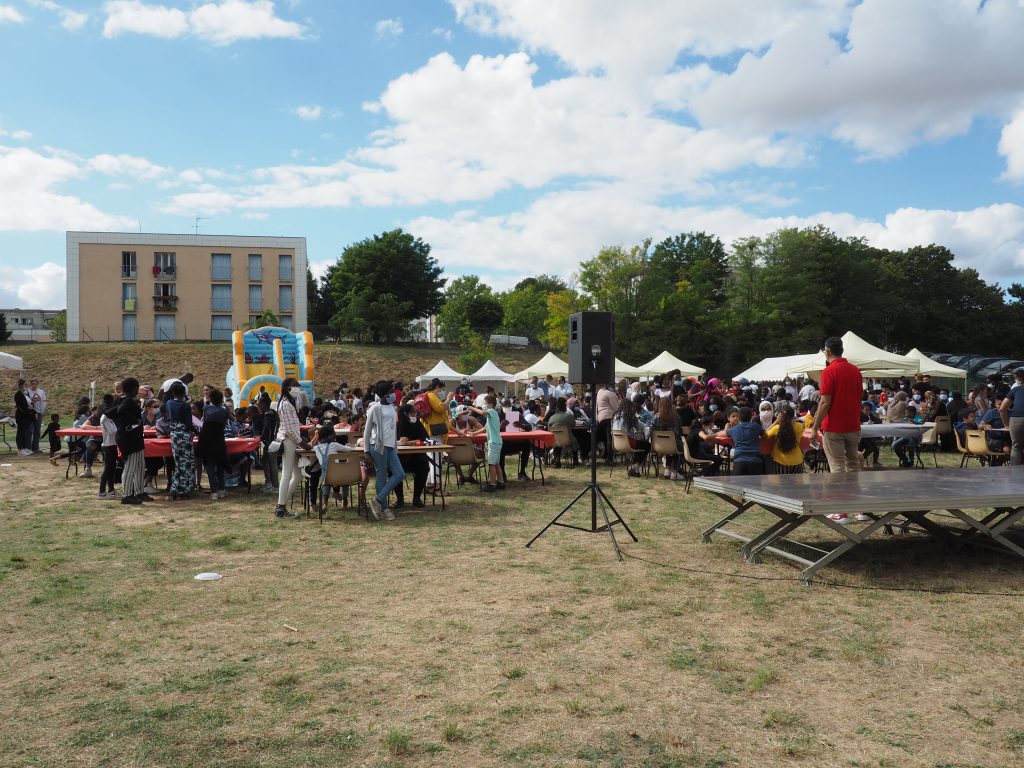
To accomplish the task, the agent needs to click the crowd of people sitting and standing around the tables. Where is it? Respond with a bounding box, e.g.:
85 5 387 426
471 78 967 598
14 354 1024 520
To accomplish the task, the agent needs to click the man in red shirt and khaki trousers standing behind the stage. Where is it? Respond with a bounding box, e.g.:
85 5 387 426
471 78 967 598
811 336 870 525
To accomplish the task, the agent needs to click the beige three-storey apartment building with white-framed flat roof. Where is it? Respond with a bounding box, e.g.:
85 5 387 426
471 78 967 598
67 231 306 341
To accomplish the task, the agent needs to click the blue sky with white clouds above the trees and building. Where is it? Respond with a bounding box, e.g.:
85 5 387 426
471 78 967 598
0 0 1024 308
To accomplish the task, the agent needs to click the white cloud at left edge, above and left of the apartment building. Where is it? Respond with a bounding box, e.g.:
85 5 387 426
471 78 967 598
0 145 132 231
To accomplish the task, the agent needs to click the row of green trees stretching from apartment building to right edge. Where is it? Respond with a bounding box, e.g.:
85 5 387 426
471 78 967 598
307 225 1024 372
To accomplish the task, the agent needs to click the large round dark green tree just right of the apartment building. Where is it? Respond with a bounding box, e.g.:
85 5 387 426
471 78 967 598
327 229 444 344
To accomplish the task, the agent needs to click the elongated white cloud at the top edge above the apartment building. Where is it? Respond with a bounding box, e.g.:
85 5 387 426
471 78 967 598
103 0 305 45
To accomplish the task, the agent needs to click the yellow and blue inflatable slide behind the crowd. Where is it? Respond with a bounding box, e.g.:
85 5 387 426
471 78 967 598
227 326 313 408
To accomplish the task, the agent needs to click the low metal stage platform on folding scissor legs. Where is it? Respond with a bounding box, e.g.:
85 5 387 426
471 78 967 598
693 467 1024 584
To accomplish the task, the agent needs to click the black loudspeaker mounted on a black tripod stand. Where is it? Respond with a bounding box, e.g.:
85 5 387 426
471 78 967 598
526 312 637 560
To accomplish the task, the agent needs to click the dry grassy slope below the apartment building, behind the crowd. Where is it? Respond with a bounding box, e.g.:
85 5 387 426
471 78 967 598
4 342 542 416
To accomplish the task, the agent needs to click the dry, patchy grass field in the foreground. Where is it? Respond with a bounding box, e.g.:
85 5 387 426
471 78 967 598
0 457 1024 768
